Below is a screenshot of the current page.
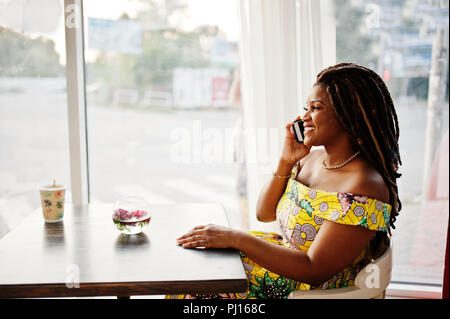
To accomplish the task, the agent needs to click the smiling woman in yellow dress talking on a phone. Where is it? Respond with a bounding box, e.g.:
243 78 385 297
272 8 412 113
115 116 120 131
169 63 401 298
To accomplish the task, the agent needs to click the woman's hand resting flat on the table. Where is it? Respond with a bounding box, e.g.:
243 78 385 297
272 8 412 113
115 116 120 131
177 224 234 248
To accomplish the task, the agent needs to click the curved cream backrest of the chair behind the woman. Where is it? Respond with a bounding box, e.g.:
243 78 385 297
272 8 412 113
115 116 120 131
355 241 392 294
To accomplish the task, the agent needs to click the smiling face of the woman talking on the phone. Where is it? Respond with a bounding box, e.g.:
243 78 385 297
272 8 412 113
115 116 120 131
302 85 349 146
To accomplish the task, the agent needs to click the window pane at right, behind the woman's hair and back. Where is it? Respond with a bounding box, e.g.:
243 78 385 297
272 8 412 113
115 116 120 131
335 0 449 285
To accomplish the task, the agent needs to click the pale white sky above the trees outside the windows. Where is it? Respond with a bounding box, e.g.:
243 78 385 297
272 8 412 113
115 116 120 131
0 0 239 63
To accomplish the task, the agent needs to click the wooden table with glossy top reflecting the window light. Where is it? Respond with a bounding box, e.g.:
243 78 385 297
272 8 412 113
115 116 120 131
0 203 247 297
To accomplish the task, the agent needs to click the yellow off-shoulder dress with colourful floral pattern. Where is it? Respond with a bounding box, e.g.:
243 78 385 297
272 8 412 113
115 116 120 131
167 166 391 299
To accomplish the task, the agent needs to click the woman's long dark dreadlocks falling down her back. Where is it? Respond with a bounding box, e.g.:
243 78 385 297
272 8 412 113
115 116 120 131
315 63 402 237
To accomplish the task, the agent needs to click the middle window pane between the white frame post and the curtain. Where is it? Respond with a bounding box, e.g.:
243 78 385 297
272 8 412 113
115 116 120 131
84 0 246 227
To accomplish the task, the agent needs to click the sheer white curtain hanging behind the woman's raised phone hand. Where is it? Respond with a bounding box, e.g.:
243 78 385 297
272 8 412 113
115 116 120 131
239 0 336 231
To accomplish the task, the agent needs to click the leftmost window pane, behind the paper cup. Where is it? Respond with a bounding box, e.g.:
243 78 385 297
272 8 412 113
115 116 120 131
0 0 71 237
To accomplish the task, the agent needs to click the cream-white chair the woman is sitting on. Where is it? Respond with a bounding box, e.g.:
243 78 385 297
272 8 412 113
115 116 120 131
288 242 392 299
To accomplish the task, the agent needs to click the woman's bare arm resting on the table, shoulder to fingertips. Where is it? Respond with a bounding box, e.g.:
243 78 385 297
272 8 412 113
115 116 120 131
177 220 375 285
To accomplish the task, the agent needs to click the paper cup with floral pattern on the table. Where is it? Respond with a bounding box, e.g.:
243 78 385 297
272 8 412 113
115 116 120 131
39 185 66 223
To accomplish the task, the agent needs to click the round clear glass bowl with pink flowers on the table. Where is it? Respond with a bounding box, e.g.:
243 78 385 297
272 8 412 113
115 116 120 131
113 196 151 235
